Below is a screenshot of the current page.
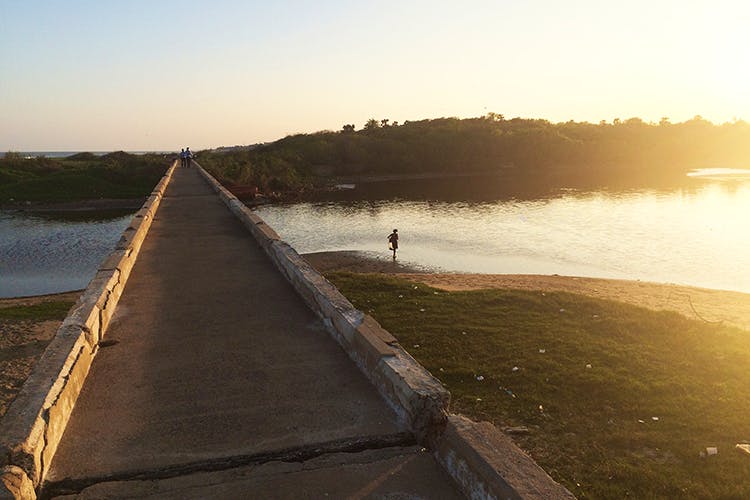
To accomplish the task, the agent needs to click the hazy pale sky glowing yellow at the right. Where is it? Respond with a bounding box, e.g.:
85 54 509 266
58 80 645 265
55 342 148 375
0 0 750 151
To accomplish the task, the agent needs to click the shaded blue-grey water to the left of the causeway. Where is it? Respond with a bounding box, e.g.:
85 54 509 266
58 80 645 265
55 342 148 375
0 211 132 298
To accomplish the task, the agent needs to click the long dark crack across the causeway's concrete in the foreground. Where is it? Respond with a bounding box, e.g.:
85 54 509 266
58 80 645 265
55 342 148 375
38 432 417 500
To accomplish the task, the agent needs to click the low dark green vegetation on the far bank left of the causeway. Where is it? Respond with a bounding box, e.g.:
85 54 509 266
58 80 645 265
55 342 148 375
0 151 169 204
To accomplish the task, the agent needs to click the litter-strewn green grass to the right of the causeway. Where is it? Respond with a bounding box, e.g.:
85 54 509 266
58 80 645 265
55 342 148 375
328 273 750 498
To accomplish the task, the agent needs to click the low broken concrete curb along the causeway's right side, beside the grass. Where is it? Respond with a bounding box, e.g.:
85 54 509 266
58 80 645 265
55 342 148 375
194 162 575 499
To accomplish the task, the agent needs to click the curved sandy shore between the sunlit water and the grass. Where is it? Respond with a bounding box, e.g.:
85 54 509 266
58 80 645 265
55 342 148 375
304 252 750 330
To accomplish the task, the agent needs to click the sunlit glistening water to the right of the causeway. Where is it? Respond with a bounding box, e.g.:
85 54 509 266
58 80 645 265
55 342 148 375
258 174 750 292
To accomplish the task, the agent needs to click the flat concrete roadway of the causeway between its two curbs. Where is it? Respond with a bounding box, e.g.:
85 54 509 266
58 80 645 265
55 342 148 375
42 168 463 498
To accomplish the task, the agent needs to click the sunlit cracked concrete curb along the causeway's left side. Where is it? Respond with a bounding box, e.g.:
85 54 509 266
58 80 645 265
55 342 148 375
0 162 177 499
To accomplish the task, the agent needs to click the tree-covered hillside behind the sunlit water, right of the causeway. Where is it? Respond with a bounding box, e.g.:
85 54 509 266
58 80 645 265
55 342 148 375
195 113 750 195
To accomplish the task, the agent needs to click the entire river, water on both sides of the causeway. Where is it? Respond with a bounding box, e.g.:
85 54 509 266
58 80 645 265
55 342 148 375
0 169 750 297
